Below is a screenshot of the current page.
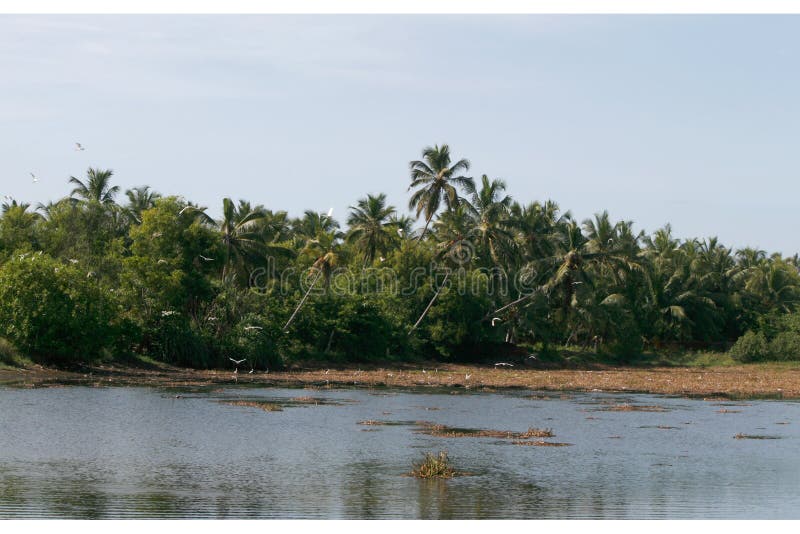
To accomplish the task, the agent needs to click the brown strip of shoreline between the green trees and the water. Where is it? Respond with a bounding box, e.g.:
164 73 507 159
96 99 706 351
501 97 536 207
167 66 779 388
0 364 800 399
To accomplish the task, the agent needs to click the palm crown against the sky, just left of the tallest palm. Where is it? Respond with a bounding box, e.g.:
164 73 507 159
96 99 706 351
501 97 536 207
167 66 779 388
347 193 396 267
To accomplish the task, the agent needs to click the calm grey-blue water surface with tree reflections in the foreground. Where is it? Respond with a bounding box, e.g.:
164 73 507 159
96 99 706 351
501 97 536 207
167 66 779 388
0 386 800 519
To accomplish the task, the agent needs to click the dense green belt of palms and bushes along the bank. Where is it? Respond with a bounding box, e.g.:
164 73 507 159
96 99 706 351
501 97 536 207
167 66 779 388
0 145 800 370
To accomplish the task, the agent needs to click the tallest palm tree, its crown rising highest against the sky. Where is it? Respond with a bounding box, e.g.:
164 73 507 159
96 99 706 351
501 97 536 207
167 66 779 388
408 145 475 240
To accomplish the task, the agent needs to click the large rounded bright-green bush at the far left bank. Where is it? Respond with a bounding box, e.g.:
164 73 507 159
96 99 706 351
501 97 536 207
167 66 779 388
0 254 114 364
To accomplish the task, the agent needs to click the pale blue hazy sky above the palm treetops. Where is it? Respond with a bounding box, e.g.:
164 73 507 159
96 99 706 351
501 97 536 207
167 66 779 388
0 15 800 254
